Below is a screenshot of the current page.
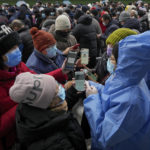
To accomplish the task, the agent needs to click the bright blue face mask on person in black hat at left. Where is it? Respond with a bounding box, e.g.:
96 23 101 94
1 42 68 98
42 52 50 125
5 48 22 67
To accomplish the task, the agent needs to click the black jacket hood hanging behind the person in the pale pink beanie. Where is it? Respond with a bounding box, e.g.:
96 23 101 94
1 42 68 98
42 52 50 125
16 104 68 143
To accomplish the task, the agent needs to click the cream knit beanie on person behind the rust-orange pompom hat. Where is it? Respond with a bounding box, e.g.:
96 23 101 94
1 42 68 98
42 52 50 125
55 15 71 31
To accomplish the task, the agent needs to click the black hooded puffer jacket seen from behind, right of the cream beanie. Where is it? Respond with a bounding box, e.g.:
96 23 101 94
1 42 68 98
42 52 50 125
72 15 97 67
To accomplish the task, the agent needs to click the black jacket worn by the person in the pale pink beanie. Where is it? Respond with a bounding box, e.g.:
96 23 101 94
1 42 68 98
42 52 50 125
16 104 86 150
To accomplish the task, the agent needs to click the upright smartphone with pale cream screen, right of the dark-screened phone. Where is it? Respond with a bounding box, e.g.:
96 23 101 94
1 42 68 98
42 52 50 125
81 48 89 65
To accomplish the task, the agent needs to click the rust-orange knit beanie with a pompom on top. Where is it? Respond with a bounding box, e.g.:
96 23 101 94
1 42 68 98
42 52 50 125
30 27 56 52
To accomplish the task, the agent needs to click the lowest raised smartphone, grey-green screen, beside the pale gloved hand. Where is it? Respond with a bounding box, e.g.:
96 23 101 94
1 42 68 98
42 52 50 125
75 71 85 91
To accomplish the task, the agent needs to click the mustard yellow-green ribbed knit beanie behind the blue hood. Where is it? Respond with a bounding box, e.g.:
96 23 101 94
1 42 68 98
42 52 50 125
106 28 137 46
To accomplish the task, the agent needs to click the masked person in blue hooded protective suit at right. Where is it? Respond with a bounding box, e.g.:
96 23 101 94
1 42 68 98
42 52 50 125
84 31 150 150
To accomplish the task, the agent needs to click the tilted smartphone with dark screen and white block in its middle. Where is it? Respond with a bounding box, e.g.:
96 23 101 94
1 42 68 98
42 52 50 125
65 51 77 71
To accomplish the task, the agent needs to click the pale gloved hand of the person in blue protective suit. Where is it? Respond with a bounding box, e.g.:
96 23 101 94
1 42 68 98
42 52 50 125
85 81 98 97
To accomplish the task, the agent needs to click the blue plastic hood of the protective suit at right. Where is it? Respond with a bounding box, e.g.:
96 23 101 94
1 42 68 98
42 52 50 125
105 31 150 91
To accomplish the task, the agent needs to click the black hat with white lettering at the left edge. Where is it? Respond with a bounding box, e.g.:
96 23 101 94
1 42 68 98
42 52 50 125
0 25 21 56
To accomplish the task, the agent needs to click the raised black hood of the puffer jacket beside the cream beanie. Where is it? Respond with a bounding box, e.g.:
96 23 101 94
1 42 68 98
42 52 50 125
78 15 92 25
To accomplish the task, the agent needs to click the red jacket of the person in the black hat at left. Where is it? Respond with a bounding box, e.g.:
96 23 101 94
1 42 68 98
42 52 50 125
0 63 67 150
